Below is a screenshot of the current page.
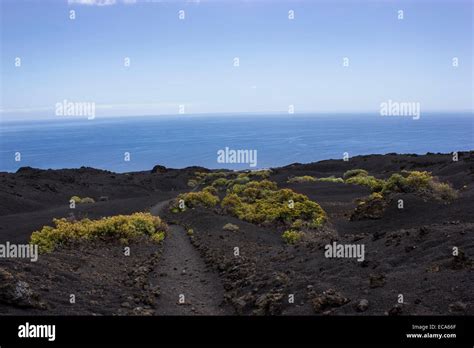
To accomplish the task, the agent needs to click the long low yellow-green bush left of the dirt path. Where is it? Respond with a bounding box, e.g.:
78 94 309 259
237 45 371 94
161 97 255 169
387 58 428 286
30 213 167 252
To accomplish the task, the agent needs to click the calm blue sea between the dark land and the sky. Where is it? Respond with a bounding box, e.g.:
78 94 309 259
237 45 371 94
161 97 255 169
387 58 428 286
0 114 474 172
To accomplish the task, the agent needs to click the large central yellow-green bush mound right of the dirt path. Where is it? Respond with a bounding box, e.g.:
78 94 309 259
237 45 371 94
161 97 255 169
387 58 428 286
221 180 326 228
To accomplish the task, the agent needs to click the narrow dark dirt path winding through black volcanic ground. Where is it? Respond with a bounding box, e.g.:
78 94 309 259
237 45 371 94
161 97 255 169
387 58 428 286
150 201 233 315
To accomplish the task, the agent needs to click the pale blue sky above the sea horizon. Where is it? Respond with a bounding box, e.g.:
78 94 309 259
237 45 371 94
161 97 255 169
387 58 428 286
0 0 473 120
